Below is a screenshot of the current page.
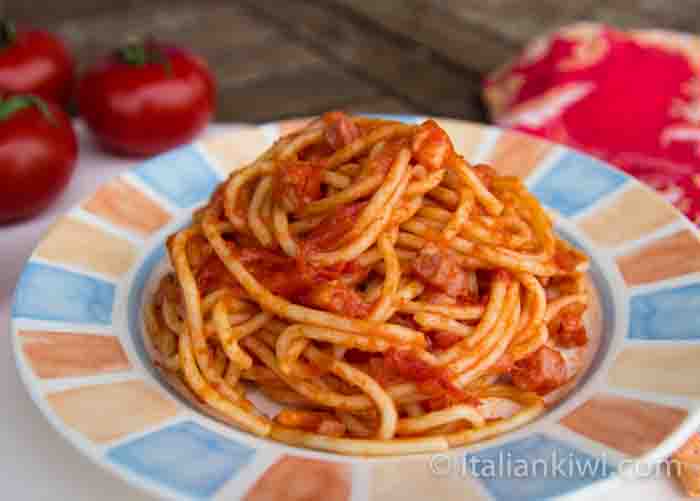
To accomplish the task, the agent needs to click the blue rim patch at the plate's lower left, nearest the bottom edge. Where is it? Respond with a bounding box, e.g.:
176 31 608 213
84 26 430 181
107 421 255 499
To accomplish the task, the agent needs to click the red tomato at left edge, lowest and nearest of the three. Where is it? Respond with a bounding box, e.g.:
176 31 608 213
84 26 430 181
0 95 78 223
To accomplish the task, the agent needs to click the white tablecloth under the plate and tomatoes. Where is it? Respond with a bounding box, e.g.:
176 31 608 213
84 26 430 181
0 124 683 501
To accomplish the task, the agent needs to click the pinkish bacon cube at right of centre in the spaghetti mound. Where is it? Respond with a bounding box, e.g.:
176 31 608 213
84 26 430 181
413 243 468 297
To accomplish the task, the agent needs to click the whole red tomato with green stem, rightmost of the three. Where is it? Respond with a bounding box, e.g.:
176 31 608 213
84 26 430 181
78 41 215 155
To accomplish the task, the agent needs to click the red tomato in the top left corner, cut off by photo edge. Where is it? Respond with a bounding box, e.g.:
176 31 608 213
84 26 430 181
0 21 75 106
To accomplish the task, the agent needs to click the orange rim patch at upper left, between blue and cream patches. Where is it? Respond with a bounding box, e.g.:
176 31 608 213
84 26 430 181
83 179 170 236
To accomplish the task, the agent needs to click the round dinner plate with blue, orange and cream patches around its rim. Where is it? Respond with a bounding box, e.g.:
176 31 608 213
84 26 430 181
11 116 700 501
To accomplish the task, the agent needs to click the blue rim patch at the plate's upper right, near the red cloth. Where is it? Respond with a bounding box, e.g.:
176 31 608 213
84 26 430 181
532 151 628 216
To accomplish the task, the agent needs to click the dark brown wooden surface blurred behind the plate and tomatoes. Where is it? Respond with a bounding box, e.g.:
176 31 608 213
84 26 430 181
0 0 700 121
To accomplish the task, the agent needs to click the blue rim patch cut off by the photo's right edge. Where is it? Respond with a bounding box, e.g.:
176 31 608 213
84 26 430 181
629 284 700 340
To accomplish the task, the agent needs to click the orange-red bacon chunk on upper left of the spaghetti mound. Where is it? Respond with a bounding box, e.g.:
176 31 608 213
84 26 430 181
272 160 322 212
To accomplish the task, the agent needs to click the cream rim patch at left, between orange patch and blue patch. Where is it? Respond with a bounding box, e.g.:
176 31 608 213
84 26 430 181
36 217 136 277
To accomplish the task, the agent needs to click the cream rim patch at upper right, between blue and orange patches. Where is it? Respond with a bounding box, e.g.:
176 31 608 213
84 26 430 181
579 185 680 247
